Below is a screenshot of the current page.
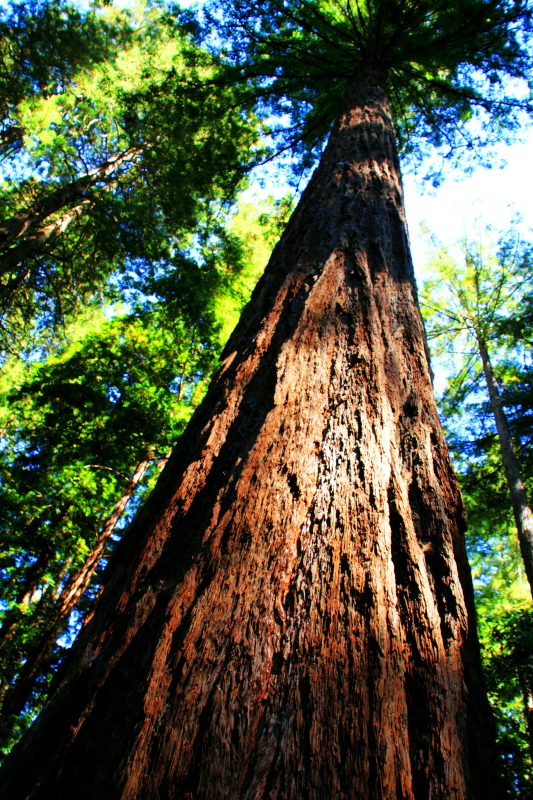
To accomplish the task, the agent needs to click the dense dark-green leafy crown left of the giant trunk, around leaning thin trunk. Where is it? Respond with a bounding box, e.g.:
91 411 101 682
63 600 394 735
0 304 214 744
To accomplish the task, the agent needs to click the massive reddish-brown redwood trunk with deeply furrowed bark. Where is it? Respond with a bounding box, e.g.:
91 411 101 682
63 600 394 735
0 71 501 800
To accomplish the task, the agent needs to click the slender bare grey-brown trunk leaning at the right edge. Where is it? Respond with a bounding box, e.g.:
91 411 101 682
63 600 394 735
477 335 533 595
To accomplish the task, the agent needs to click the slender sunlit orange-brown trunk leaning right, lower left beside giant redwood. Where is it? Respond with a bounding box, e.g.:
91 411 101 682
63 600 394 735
1 460 150 718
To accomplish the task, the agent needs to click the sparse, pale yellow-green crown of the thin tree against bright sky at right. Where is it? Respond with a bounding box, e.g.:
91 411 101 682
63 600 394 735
420 228 533 424
